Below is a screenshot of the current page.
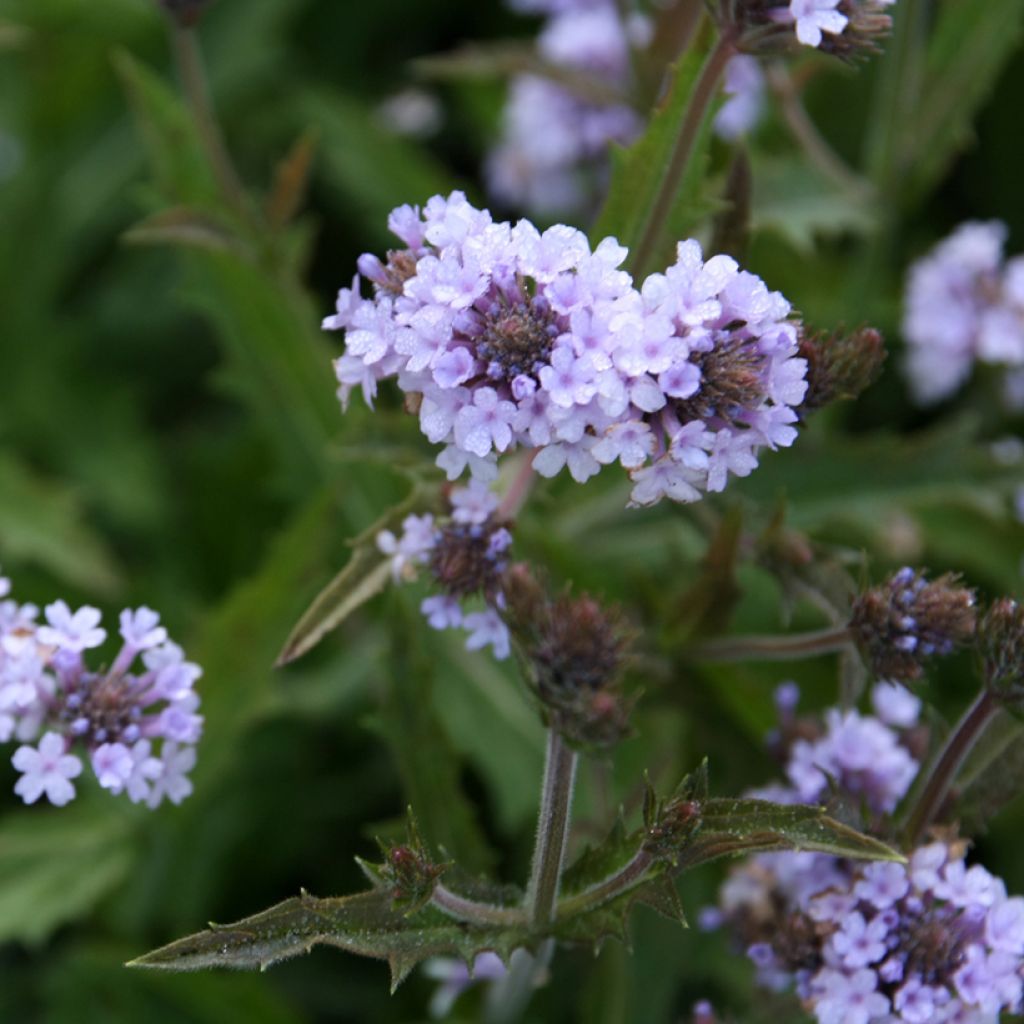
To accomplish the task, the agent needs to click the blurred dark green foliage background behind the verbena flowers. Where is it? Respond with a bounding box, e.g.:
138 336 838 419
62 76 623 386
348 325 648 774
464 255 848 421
0 0 1024 1024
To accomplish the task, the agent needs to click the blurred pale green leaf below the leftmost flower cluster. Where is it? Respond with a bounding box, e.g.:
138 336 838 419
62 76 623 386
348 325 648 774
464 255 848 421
0 798 136 943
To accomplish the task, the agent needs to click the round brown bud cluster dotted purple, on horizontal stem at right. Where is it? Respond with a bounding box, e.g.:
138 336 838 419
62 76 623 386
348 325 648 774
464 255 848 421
850 566 978 682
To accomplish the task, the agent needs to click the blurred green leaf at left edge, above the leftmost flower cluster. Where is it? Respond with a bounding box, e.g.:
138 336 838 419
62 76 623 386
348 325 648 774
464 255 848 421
0 452 120 593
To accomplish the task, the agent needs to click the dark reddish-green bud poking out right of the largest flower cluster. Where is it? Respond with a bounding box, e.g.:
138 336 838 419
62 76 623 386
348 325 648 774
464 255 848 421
800 327 886 413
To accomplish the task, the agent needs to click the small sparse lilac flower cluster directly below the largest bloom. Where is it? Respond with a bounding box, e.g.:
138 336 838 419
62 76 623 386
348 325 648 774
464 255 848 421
377 481 512 658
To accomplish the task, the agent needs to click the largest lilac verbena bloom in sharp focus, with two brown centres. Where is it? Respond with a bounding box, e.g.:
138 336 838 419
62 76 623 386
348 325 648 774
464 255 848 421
324 193 807 505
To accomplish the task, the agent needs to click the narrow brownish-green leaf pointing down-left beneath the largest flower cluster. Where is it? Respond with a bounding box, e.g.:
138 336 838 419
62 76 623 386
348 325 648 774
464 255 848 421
276 485 436 667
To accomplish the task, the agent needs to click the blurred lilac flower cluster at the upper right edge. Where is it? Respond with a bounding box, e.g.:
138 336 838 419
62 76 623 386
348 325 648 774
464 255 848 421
903 220 1024 403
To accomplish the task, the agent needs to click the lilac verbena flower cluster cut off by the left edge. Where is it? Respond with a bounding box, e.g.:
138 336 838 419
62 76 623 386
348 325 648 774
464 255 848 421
0 578 203 807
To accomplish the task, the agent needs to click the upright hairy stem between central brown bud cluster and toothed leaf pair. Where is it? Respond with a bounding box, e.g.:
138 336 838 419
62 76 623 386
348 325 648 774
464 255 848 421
526 729 578 928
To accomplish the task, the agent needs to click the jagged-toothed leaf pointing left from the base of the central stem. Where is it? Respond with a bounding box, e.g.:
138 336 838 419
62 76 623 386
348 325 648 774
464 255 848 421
128 888 534 990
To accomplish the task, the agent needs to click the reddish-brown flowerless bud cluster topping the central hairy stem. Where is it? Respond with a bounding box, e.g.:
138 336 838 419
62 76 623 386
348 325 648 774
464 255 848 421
505 564 632 748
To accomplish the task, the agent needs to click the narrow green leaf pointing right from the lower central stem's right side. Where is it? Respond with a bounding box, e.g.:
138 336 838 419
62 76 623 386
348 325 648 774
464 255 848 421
679 798 904 869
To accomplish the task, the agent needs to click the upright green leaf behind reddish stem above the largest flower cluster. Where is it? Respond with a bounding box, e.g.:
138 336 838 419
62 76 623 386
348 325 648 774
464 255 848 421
591 49 716 269
